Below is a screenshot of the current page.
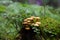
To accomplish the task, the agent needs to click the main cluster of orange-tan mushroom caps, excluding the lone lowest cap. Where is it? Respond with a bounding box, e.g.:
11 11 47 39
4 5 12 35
23 16 41 26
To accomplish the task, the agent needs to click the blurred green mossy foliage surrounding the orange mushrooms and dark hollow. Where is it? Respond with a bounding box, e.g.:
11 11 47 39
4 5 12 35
0 3 60 40
